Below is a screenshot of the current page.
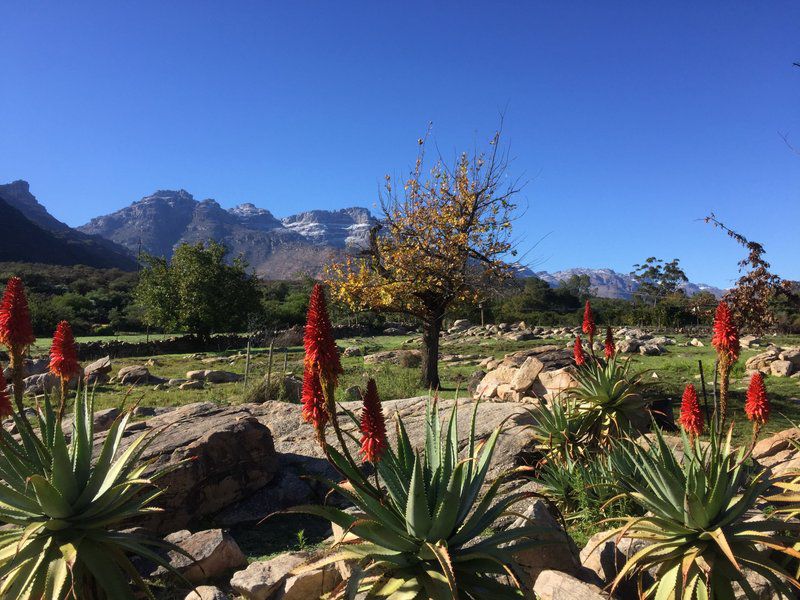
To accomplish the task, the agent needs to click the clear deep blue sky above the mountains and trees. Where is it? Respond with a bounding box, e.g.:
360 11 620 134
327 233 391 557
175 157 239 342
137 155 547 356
0 0 800 286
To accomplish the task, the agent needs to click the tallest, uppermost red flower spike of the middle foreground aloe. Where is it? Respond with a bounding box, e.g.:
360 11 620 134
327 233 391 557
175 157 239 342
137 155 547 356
303 283 344 386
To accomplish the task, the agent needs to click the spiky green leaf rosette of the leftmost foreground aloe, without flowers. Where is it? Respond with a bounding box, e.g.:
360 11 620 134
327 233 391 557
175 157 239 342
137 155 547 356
0 392 185 600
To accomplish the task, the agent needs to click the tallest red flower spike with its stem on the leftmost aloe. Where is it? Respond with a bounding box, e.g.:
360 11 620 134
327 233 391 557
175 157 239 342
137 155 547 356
0 277 36 415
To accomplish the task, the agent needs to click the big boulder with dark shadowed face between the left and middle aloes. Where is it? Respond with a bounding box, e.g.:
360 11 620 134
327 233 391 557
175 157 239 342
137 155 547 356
95 402 280 532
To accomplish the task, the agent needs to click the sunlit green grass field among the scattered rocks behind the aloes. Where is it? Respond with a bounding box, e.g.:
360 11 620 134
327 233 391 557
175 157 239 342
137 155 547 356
64 336 800 437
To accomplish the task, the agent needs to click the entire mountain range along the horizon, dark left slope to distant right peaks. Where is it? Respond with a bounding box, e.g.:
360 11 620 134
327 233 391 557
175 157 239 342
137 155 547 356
0 180 723 298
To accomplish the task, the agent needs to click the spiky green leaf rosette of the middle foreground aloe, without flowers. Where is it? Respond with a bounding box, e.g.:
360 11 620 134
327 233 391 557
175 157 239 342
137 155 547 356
290 402 542 600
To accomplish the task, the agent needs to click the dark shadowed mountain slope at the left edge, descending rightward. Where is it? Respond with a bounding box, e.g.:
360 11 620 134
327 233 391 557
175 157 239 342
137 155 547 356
0 180 136 270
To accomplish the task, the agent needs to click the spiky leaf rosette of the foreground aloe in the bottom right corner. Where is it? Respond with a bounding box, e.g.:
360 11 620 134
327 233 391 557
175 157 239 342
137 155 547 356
607 429 800 600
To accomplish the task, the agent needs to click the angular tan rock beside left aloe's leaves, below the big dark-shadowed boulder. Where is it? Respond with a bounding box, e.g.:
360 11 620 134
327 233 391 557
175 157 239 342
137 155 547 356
166 529 247 583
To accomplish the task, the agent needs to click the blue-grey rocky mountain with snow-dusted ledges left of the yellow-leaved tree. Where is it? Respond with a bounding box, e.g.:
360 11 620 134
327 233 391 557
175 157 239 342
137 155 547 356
78 190 376 279
